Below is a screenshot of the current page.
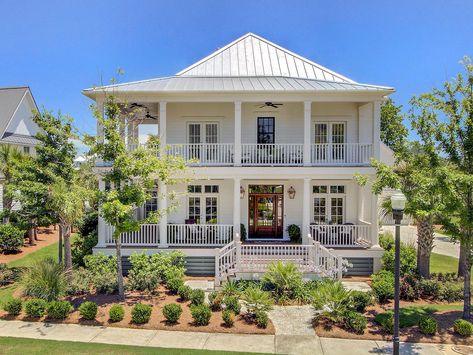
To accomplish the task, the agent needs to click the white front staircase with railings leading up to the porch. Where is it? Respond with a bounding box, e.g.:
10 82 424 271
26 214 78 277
215 239 343 285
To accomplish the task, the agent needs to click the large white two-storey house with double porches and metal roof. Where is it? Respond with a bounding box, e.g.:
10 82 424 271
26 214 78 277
83 33 394 280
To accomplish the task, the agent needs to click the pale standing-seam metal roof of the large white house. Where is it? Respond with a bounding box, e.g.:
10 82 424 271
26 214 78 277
84 33 394 96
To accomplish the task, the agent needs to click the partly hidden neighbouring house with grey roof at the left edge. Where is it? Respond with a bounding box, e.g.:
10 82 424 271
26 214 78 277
0 86 39 210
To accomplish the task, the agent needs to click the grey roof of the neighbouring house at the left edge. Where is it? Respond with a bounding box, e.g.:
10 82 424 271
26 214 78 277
0 86 38 145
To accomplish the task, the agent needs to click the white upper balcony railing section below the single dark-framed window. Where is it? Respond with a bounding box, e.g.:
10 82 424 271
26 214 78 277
241 144 304 166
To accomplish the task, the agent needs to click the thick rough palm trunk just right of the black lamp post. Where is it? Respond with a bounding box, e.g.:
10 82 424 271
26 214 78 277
417 217 435 279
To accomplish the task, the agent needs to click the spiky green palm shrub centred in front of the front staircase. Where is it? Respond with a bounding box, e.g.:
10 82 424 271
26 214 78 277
261 261 302 298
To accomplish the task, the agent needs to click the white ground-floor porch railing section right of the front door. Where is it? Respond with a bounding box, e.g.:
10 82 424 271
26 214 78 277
309 224 371 248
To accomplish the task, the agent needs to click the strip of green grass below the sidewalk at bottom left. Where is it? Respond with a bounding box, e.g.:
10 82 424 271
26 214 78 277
0 337 262 355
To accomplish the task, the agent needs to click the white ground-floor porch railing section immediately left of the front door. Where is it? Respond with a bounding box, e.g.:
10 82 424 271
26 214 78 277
167 224 233 247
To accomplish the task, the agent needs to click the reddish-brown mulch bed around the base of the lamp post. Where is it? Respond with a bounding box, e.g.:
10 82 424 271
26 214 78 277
314 301 473 345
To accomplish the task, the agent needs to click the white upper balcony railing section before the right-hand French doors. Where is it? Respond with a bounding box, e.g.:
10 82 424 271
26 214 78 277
311 143 373 166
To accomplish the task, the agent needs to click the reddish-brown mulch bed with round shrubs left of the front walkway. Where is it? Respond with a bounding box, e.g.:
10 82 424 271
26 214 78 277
0 286 274 334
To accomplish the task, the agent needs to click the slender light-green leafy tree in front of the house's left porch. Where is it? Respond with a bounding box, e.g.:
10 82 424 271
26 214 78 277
86 95 185 298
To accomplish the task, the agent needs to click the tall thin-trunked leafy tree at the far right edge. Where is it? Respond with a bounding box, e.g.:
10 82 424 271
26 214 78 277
411 57 473 319
